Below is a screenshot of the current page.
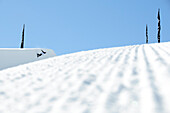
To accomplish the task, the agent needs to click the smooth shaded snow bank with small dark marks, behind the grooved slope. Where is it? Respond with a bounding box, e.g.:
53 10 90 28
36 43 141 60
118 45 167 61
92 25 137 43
0 48 55 70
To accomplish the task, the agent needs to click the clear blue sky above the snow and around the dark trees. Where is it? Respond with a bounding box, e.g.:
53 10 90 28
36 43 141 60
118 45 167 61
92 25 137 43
0 0 170 55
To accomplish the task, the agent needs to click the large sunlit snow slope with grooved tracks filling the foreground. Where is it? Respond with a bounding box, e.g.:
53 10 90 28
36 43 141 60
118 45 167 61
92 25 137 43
0 42 170 113
